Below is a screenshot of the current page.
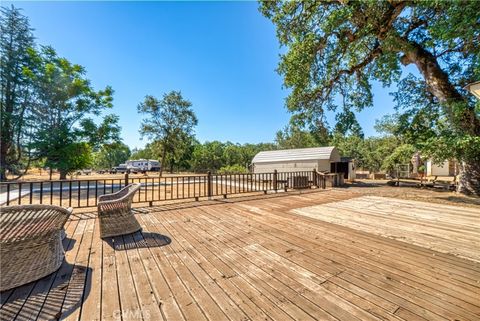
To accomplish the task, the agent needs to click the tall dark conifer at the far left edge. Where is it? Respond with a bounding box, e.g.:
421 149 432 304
0 6 35 180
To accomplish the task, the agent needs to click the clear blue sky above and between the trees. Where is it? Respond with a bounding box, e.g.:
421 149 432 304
10 2 402 148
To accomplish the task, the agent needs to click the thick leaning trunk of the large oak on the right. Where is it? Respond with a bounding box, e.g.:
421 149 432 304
401 39 480 195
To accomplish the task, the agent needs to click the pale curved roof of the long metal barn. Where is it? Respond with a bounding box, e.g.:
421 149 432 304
252 146 340 163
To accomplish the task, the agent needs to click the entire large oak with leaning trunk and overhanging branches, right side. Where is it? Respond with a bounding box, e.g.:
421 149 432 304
260 0 480 194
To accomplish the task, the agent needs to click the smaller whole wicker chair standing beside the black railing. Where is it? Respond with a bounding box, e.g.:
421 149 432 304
98 184 142 238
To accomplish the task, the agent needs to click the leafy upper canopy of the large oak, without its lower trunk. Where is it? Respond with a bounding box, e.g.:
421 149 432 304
260 0 480 121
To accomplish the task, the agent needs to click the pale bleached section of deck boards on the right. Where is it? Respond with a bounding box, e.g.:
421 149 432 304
293 196 480 262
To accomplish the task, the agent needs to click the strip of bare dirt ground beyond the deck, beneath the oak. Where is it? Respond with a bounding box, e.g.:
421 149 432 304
344 180 480 206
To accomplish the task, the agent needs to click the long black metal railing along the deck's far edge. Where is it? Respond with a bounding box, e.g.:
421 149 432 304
0 171 336 208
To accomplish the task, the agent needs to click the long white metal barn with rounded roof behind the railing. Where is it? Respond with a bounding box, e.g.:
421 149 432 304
252 146 340 173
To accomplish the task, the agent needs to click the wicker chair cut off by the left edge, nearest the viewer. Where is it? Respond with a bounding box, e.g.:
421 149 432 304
0 205 72 291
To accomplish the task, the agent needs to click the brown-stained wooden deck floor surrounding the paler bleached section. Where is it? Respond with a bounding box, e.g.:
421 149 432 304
0 191 480 321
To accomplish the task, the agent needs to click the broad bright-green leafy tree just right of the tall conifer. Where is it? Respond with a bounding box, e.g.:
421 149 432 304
29 47 120 178
